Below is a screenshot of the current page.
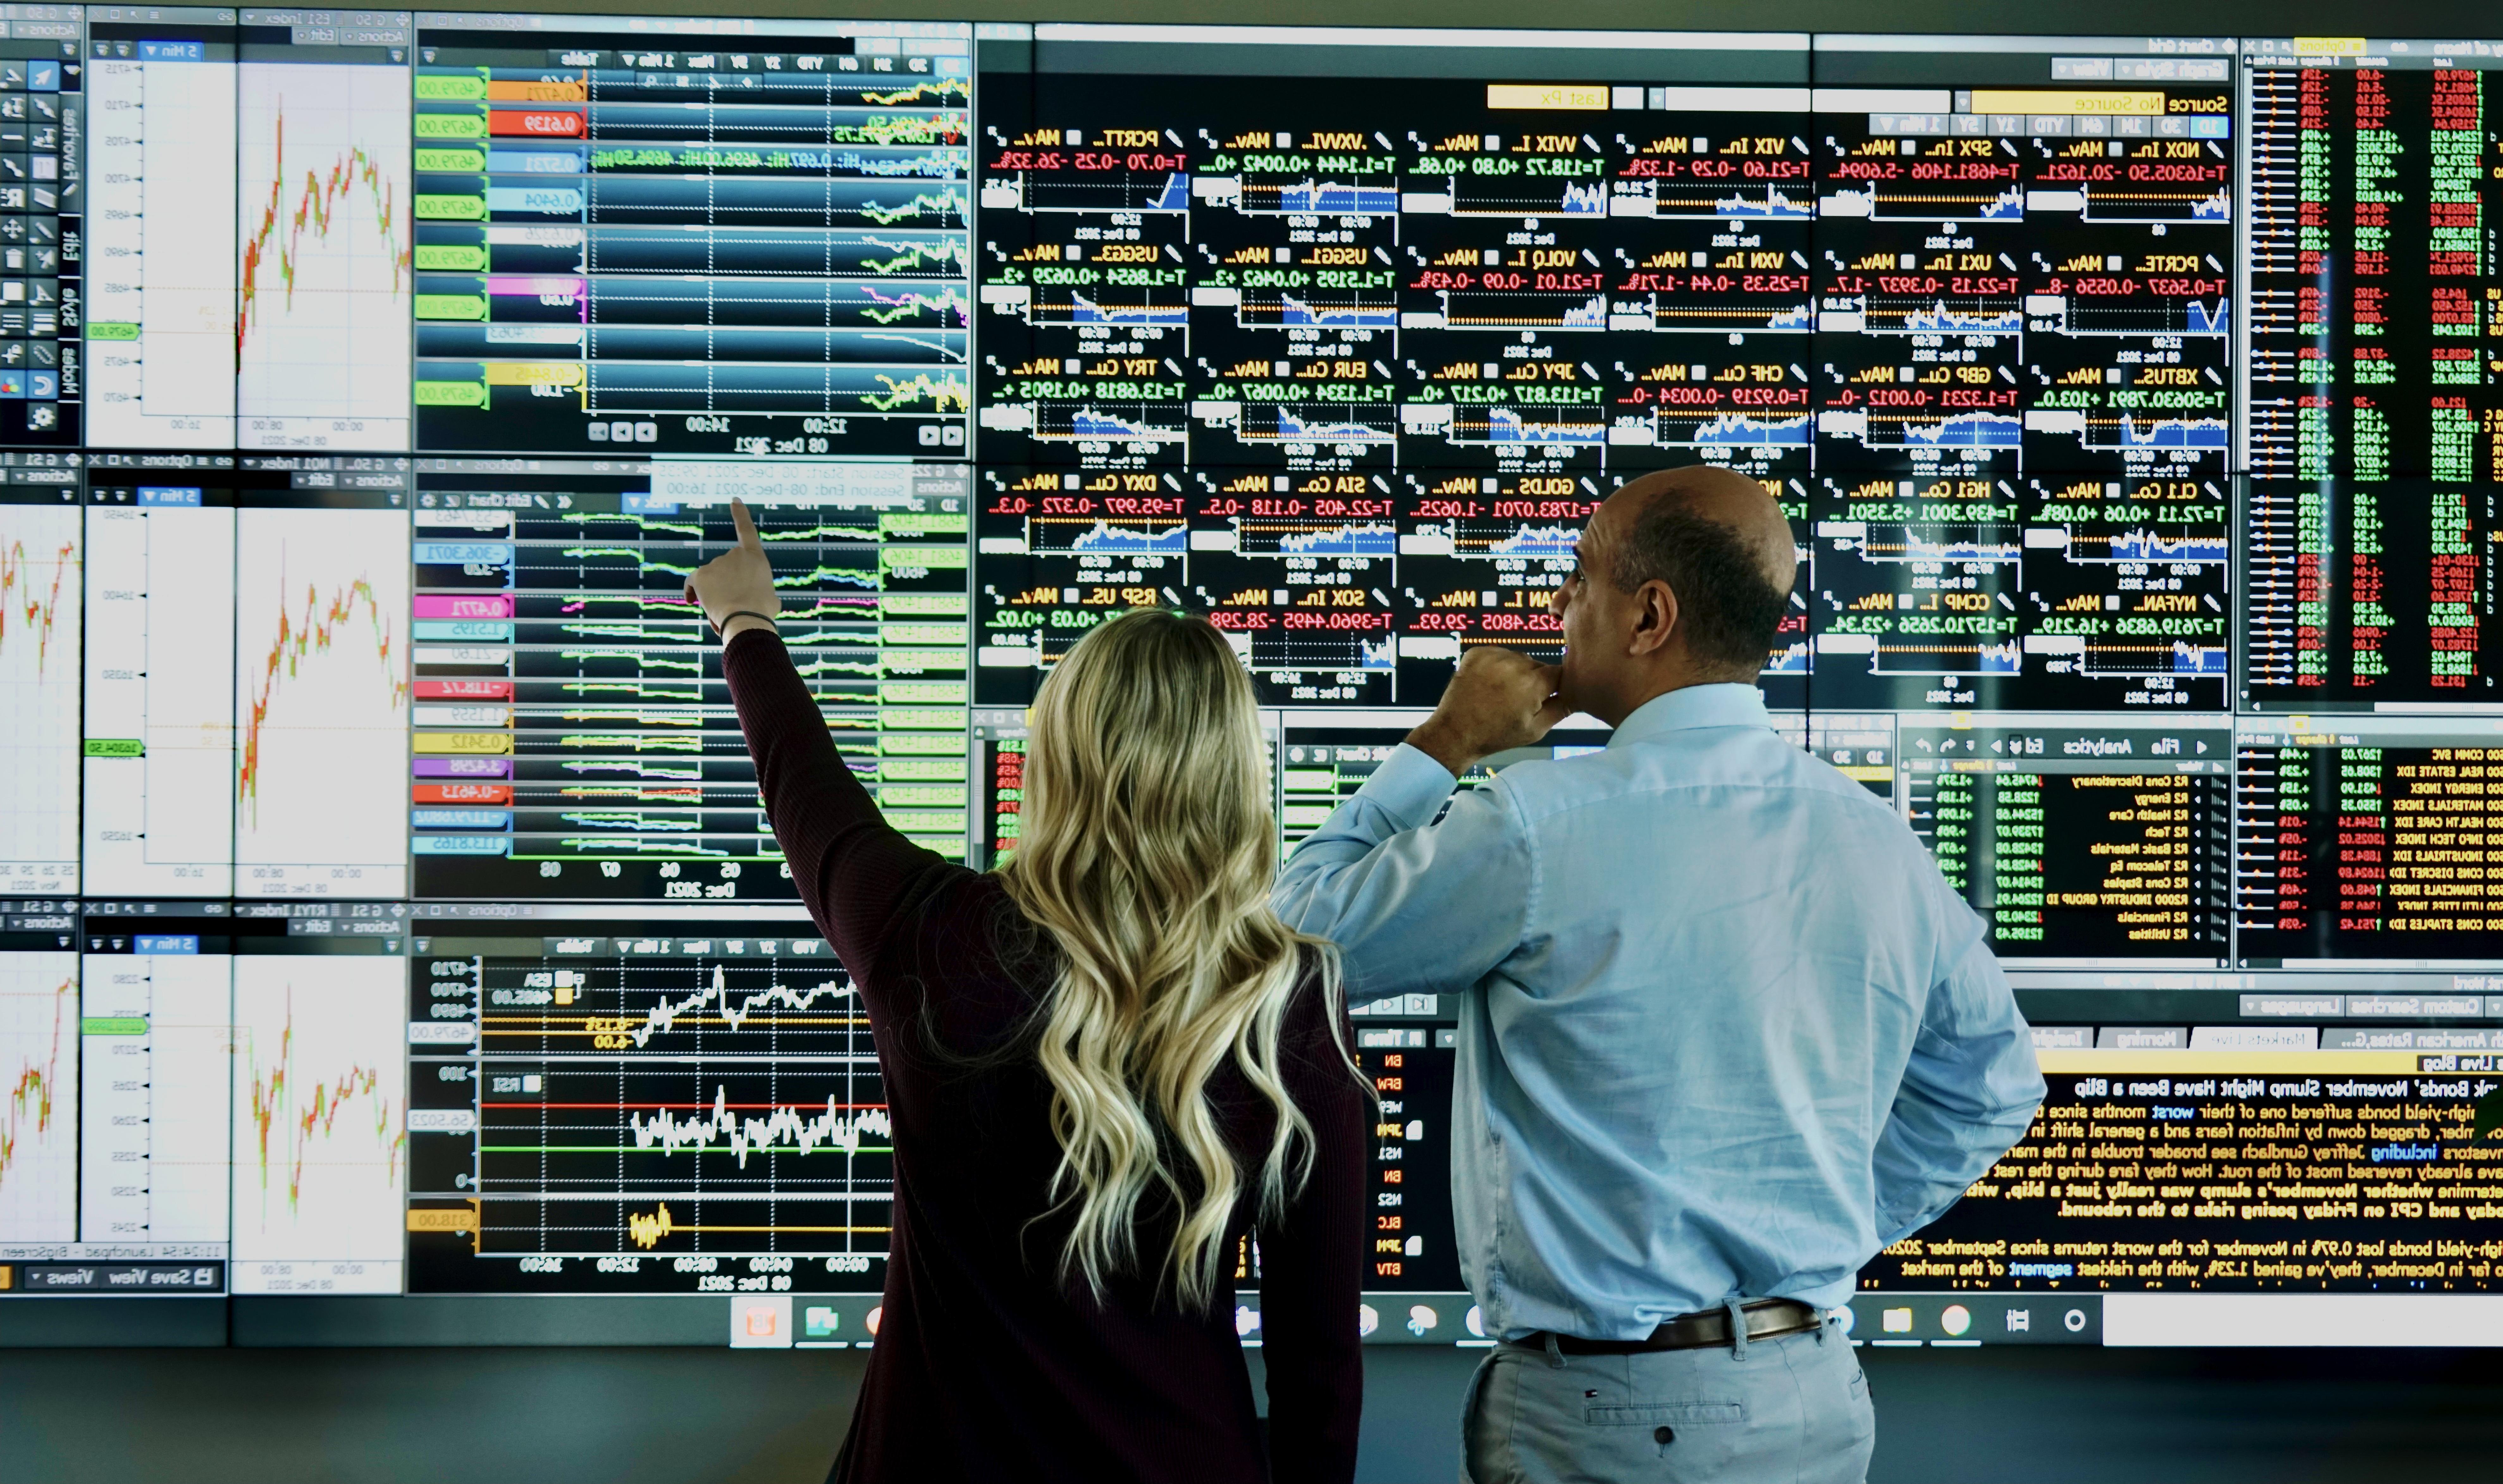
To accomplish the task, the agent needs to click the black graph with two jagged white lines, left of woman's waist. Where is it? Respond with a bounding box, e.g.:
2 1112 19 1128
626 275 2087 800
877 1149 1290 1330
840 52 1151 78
435 936 894 1271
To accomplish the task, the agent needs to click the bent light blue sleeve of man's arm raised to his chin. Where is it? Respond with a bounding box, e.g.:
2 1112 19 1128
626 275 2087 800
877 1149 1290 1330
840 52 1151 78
1272 743 1537 999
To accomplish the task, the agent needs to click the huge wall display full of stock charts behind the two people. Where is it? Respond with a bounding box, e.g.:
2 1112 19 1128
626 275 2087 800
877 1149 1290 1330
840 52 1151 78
0 5 2503 1346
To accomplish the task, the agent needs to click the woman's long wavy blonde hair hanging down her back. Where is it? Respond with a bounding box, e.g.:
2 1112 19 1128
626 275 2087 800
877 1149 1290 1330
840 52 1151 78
999 608 1354 1309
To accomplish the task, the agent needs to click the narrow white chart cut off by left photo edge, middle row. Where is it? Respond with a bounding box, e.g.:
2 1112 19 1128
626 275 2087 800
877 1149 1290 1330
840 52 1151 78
0 506 83 893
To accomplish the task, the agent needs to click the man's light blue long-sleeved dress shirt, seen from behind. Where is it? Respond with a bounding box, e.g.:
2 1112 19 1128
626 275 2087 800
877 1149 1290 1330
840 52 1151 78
1277 686 2043 1339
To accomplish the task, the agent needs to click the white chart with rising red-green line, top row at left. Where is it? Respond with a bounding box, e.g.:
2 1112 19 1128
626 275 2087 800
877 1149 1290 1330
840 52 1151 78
235 63 410 448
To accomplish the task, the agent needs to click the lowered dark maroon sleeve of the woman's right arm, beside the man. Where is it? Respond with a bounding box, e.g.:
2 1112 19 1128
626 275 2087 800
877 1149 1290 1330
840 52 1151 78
1259 994 1369 1484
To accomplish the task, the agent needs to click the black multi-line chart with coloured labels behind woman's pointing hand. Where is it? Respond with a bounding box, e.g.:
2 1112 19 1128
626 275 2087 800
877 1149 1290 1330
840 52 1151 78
410 465 966 896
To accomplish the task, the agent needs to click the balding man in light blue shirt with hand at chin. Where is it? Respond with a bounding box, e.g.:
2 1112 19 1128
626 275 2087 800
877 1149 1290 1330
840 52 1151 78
1277 468 2043 1484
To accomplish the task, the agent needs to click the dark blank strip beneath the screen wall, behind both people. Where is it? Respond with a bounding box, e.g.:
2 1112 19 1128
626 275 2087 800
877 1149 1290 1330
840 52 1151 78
0 1346 2503 1484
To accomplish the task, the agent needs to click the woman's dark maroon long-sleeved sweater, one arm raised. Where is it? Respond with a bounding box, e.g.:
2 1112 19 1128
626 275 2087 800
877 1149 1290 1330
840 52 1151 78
723 631 1367 1484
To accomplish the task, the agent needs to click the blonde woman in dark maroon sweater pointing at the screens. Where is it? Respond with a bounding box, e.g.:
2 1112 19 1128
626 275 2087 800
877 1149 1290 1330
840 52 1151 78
688 506 1367 1484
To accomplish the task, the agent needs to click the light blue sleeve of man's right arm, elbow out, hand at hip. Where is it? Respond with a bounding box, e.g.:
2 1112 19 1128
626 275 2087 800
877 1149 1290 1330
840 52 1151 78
1875 921 2043 1246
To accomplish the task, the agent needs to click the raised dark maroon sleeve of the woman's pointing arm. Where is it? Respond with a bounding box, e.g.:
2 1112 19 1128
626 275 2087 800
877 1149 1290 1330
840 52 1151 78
721 628 971 986
